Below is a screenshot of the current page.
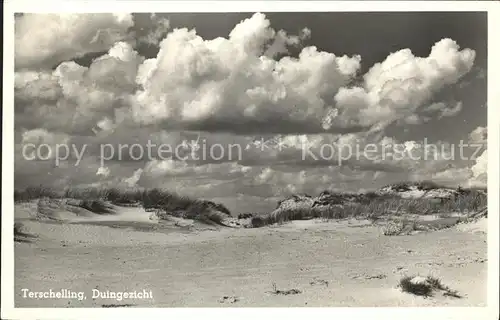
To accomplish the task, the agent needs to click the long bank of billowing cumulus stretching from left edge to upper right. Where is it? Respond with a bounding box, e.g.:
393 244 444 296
16 13 475 138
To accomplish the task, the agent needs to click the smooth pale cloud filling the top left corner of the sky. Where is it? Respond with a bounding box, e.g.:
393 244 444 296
15 13 134 69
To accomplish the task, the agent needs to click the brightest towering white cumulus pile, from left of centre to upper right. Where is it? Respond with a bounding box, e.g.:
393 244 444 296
129 25 475 132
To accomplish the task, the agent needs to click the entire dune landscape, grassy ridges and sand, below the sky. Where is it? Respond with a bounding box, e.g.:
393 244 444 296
14 181 487 307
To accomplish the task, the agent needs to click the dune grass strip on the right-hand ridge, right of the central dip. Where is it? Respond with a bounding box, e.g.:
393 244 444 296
248 183 487 229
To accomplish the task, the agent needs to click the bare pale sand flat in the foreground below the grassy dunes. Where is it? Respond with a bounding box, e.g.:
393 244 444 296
15 204 487 307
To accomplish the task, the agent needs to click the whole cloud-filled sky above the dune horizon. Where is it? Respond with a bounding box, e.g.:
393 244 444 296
15 12 487 212
